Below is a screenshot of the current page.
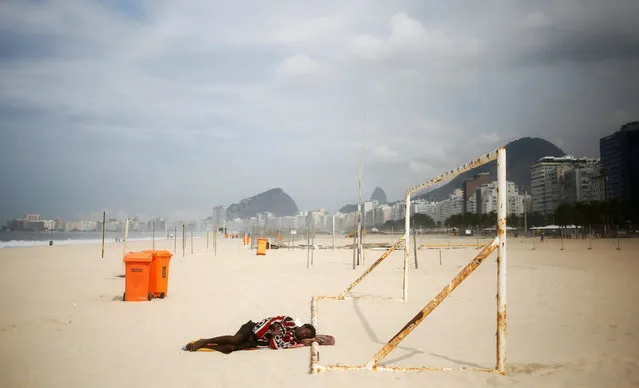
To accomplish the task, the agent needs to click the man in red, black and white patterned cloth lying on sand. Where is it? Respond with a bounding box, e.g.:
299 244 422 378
184 315 316 354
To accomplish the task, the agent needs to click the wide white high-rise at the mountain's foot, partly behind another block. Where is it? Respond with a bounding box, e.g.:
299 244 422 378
530 156 599 214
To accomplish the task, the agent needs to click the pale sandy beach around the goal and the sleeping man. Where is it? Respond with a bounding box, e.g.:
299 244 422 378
0 238 639 387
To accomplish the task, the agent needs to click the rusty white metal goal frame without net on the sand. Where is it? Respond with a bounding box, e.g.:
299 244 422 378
311 147 508 374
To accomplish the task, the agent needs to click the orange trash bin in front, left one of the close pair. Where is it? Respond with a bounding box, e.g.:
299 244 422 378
122 252 153 302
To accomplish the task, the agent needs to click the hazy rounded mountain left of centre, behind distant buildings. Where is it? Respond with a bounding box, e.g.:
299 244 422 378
226 188 298 219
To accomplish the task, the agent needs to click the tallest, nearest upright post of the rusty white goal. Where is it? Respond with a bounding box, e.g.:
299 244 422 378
495 148 508 374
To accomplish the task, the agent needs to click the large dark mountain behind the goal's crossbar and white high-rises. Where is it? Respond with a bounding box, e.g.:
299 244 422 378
416 137 566 201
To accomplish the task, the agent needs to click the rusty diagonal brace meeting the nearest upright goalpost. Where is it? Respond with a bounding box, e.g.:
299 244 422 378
365 237 499 369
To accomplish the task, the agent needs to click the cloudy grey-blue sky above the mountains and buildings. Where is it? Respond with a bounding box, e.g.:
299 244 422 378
0 0 639 222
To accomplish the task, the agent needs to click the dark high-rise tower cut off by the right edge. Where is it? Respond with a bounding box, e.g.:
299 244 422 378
599 121 639 200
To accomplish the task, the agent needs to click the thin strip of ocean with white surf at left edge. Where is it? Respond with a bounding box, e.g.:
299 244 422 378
0 230 200 248
